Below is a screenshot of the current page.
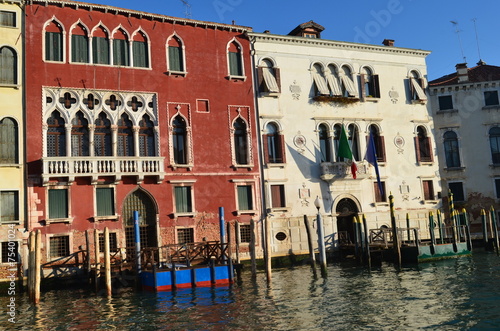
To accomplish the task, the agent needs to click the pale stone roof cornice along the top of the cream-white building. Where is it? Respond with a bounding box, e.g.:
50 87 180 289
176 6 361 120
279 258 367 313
247 32 431 57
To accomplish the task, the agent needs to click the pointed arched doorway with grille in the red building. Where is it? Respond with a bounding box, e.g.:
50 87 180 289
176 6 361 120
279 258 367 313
122 189 158 247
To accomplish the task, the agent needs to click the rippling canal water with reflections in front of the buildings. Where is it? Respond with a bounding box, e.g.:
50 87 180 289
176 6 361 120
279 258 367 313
0 252 500 330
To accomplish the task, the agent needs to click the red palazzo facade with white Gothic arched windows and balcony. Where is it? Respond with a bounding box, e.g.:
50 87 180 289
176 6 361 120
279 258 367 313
25 0 261 260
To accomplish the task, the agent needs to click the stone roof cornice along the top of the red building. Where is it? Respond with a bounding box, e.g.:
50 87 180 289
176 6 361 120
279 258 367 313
26 0 252 33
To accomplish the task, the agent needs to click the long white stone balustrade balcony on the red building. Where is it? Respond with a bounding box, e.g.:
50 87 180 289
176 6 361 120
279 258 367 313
42 156 165 185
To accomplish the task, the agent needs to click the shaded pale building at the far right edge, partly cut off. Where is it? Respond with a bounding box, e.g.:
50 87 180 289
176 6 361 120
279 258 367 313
429 61 500 232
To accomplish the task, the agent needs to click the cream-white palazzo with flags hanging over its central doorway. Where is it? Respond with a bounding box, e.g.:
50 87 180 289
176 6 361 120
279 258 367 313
248 21 441 256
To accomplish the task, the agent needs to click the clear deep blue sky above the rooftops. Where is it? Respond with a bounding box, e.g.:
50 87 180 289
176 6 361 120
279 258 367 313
79 0 500 80
